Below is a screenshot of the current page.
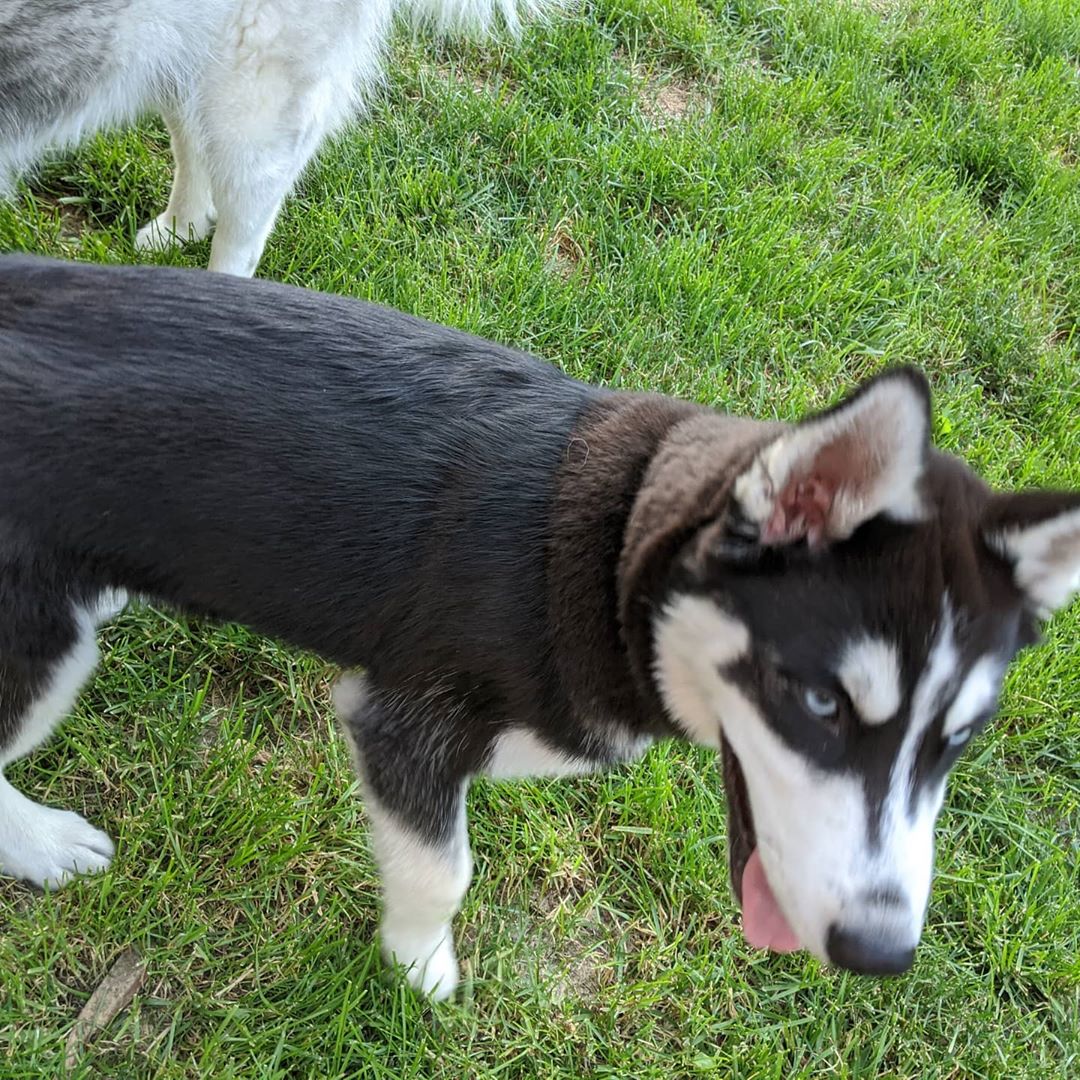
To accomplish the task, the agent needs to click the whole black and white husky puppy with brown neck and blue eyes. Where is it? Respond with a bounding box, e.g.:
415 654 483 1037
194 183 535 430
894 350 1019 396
0 258 1080 996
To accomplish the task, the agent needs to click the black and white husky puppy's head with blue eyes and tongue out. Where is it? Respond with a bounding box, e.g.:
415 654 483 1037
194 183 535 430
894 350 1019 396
653 368 1080 974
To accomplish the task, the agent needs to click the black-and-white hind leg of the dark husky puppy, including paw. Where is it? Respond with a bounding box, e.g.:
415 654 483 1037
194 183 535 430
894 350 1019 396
0 581 118 888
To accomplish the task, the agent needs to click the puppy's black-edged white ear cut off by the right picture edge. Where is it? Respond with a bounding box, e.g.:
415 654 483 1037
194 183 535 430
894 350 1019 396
982 491 1080 618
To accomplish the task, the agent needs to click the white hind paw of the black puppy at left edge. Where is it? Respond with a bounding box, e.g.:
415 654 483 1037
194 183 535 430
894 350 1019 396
0 800 116 889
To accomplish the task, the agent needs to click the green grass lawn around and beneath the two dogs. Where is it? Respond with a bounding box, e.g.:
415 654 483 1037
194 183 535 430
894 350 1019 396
0 0 1080 1080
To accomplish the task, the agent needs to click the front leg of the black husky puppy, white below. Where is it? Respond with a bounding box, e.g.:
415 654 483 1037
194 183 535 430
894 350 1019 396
334 676 472 1000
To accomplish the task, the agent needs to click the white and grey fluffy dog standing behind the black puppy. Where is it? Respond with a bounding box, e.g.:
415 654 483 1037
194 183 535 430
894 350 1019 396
0 0 557 275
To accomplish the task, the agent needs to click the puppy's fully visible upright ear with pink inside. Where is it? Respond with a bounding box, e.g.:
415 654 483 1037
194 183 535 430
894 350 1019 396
734 367 930 545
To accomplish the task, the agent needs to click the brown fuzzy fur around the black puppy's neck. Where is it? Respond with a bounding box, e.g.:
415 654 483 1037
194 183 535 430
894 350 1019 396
548 394 782 737
